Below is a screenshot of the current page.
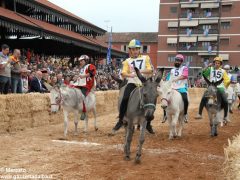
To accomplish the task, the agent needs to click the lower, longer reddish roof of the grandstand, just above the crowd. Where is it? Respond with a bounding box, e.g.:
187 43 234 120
0 7 123 53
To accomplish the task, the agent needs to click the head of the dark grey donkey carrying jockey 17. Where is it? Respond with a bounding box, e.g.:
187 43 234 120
134 67 162 121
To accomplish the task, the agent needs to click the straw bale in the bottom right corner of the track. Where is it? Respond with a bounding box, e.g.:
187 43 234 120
224 134 240 179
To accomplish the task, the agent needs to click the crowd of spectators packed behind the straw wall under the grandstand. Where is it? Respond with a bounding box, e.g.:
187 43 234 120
0 44 120 94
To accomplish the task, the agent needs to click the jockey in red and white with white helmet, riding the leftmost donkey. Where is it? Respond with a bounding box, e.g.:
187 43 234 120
78 55 96 120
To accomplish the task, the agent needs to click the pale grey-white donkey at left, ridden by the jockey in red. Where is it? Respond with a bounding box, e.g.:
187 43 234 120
50 86 98 137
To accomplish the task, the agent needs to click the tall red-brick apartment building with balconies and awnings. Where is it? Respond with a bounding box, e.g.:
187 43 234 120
157 0 240 78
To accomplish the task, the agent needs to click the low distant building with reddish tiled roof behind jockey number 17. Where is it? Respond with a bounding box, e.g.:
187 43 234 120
98 32 158 68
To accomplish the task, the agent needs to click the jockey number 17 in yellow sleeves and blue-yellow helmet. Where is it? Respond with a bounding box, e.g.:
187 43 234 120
113 39 154 134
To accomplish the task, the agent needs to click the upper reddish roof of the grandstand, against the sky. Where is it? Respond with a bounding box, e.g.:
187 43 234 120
35 0 106 32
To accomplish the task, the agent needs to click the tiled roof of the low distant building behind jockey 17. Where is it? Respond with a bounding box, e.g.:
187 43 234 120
98 32 158 43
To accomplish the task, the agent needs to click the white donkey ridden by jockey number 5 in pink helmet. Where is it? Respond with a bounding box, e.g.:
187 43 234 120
158 81 184 139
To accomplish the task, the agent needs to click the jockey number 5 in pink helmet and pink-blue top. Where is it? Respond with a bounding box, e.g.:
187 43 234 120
162 54 189 123
